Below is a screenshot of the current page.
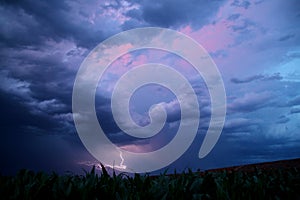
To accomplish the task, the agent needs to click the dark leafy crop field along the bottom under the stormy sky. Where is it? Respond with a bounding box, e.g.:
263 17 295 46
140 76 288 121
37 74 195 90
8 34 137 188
0 163 300 200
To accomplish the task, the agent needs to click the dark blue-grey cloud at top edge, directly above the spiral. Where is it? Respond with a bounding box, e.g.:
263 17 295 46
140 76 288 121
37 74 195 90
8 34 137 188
123 0 224 28
